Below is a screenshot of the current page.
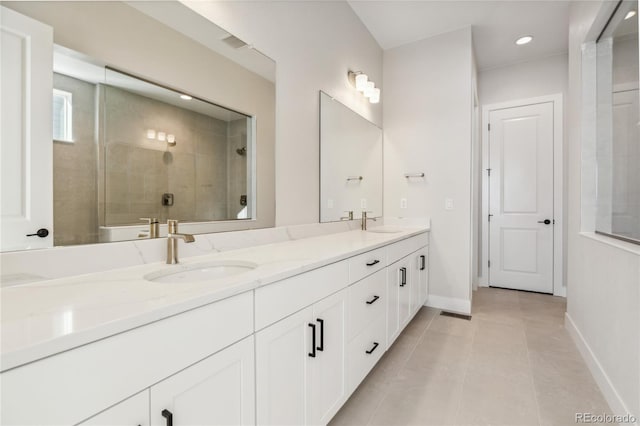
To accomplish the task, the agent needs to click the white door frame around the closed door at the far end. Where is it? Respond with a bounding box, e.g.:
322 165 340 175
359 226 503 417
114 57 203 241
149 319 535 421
478 93 567 297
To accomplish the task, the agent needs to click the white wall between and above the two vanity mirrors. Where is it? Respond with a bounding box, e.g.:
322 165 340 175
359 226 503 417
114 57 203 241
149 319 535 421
184 1 386 226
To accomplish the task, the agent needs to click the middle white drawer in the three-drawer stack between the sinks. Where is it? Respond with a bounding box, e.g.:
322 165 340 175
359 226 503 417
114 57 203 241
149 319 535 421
347 270 387 340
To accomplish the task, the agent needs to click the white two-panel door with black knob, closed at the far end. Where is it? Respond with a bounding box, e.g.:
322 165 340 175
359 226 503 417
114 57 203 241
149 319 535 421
489 102 554 293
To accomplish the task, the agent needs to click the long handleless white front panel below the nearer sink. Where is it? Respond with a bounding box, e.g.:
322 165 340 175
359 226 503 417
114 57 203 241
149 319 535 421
0 292 253 425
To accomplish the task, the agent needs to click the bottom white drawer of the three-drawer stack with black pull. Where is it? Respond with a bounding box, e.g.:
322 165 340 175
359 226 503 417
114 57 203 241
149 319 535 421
347 318 387 393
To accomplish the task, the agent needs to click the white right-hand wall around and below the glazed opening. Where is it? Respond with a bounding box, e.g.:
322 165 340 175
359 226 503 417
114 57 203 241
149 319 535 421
566 2 640 418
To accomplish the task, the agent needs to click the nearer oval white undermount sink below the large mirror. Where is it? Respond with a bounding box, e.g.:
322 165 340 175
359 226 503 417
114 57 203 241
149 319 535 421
144 261 258 283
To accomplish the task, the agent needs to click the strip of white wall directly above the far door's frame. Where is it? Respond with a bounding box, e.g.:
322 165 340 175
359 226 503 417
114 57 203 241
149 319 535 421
478 54 568 105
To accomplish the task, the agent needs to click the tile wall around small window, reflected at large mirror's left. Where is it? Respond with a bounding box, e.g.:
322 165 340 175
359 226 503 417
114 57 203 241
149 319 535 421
53 73 98 246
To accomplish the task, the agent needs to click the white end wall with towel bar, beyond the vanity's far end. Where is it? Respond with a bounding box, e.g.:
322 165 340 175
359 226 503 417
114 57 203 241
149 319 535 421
383 28 473 311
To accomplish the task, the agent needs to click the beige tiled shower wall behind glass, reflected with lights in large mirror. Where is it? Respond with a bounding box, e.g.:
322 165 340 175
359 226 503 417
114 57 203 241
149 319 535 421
104 86 237 226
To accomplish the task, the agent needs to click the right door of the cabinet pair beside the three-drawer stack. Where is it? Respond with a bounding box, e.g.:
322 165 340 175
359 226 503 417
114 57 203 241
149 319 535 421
307 289 347 425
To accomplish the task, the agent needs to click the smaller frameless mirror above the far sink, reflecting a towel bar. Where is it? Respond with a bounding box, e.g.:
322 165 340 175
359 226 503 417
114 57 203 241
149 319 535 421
320 92 383 222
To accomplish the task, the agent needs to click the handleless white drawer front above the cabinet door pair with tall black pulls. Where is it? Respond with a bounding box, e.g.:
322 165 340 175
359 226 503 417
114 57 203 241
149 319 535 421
256 260 349 331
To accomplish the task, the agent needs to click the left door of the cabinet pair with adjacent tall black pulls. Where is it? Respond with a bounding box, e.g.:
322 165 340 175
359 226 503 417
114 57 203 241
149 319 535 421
256 307 317 425
